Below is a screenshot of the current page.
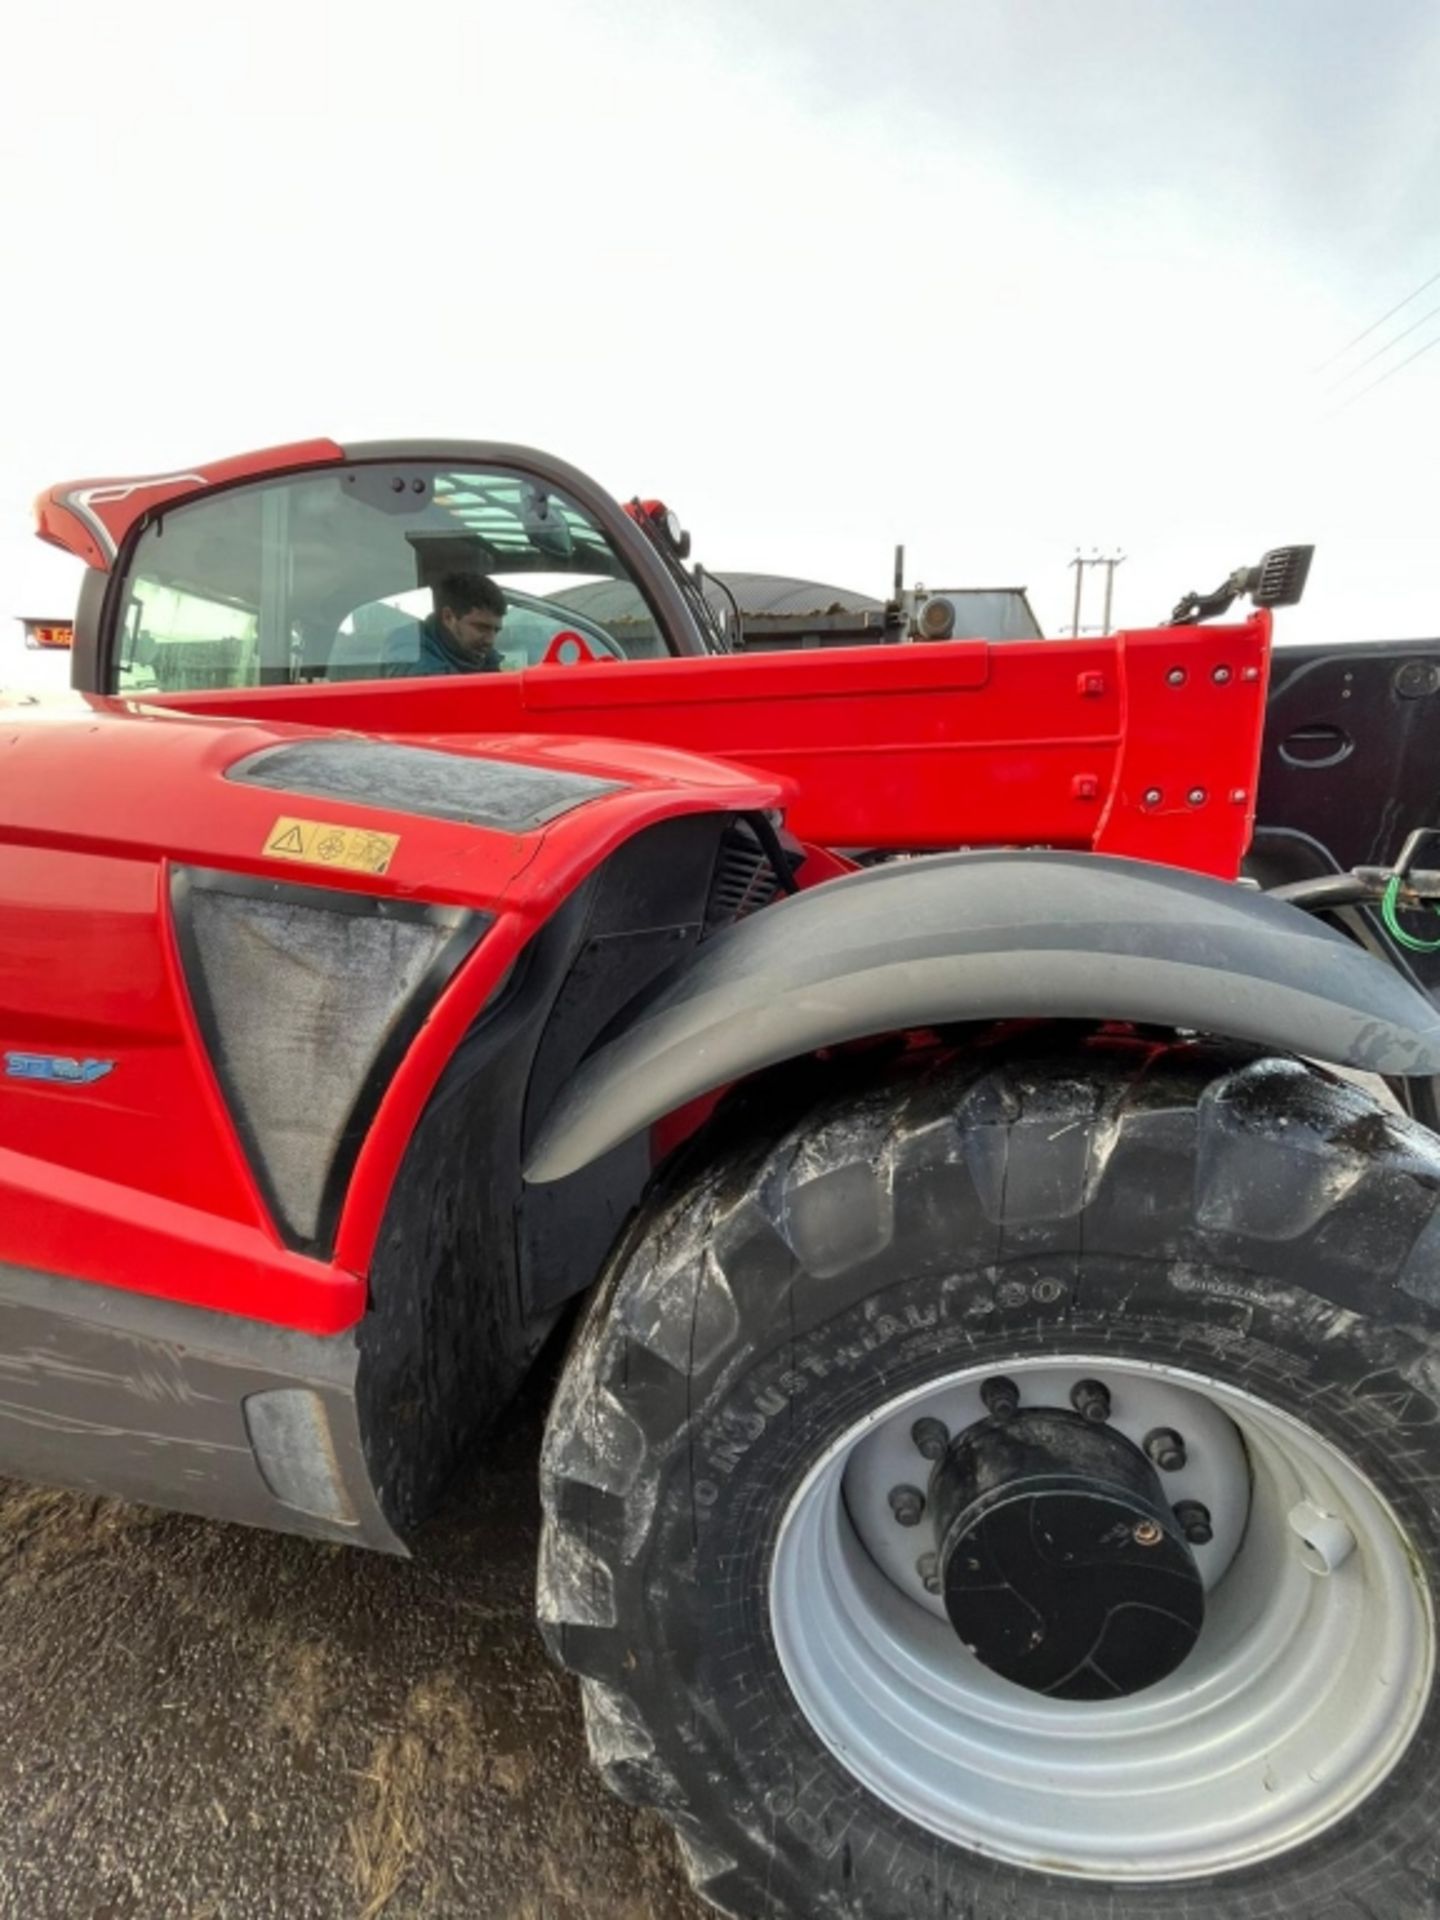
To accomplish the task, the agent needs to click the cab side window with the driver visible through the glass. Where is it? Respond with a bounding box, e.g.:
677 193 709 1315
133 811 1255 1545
113 463 666 693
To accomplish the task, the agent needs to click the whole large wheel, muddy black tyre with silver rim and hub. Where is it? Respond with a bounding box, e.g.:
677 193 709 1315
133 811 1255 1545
540 1035 1440 1920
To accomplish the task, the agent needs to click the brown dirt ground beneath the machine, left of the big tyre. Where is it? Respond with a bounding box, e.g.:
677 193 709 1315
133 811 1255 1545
0 1374 708 1920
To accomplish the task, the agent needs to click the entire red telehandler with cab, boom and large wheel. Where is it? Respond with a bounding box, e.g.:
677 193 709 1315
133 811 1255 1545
0 442 1440 1920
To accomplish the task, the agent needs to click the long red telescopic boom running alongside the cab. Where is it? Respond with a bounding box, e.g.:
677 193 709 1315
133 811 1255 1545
132 612 1269 879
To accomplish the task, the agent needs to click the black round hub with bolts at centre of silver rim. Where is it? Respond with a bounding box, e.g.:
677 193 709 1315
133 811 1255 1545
927 1407 1206 1699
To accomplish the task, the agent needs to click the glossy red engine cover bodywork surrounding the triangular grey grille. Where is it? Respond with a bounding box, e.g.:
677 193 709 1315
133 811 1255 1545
0 699 785 1332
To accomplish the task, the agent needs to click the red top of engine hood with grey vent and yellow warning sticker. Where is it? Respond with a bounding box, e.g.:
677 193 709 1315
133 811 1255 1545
0 697 787 910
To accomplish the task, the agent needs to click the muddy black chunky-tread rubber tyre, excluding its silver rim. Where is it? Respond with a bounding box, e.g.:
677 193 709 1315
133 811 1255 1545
540 1037 1440 1920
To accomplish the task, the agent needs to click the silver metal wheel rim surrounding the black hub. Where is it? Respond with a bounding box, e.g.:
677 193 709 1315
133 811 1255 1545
770 1356 1436 1882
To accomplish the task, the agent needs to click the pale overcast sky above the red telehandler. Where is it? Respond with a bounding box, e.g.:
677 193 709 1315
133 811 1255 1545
0 0 1440 691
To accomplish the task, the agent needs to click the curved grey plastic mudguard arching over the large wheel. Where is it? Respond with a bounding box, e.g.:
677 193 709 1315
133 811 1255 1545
526 852 1440 1181
